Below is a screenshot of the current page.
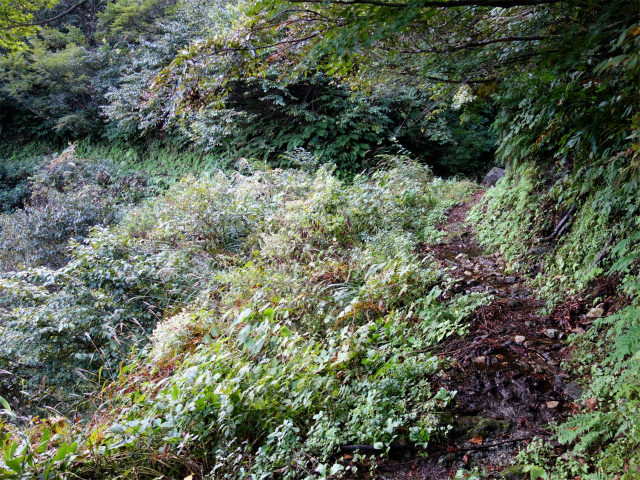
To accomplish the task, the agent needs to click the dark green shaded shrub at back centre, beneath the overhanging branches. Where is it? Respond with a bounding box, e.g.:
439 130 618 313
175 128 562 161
182 74 394 176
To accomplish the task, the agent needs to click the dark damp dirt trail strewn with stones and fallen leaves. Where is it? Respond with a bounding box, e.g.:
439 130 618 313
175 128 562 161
364 192 581 480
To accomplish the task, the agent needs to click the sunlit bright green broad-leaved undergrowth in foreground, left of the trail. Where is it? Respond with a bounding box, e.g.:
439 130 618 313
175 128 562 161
91 309 451 478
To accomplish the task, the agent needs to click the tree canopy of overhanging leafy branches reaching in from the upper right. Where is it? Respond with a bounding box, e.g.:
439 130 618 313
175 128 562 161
149 0 640 176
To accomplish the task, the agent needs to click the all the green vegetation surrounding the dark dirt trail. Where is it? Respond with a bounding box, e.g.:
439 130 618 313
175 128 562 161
0 0 640 480
